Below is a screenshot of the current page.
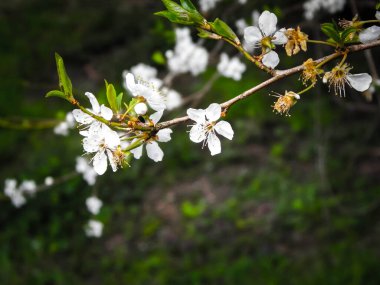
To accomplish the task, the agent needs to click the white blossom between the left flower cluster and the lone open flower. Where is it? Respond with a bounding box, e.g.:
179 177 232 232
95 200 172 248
131 111 173 162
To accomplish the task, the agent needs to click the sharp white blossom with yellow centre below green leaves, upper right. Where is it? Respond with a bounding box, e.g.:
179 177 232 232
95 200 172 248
244 11 288 68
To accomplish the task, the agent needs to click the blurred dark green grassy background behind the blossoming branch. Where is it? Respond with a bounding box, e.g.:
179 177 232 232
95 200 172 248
0 0 380 285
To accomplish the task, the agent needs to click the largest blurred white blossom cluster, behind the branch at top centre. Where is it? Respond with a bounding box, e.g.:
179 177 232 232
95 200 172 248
165 28 209 76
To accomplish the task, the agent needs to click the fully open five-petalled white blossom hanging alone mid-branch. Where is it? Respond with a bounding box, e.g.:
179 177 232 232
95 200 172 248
187 103 234 155
